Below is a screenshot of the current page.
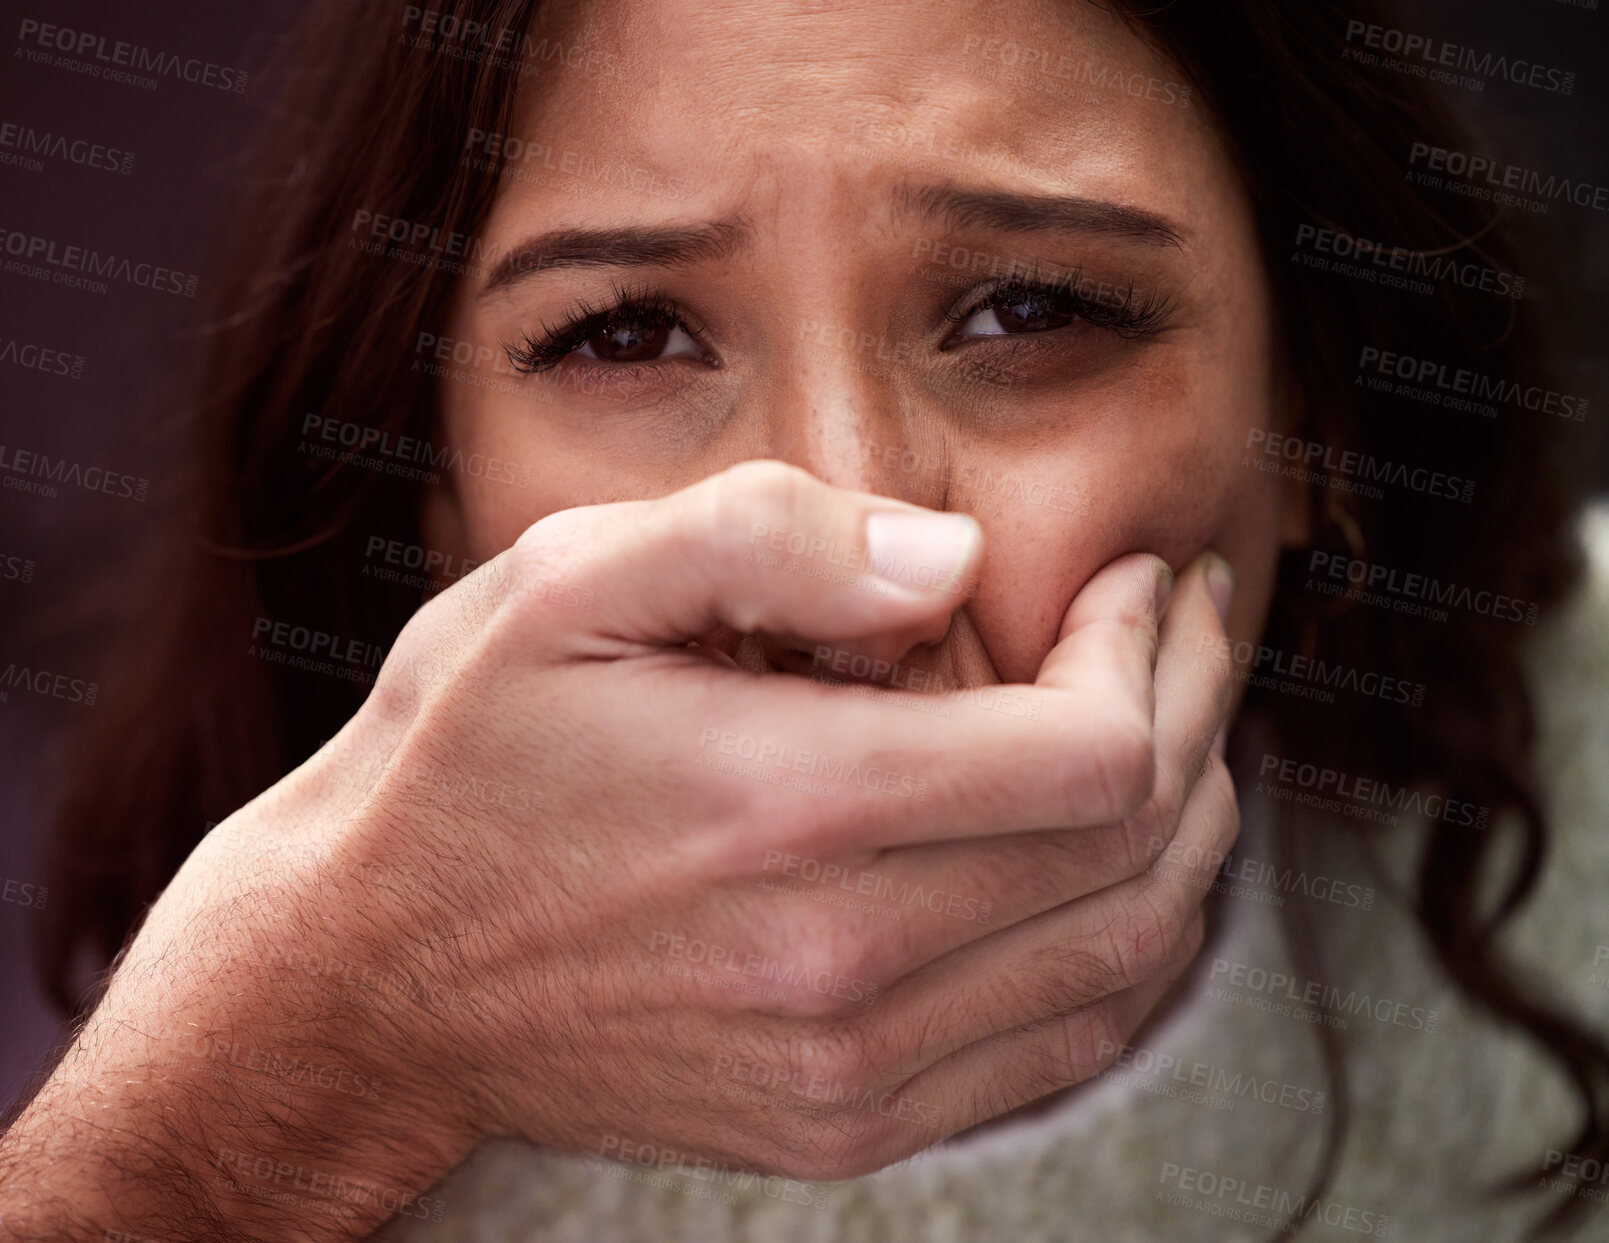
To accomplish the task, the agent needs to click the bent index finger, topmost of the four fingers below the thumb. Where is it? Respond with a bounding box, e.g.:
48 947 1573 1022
678 555 1171 855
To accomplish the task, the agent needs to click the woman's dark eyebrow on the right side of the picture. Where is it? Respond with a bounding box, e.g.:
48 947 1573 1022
895 182 1186 249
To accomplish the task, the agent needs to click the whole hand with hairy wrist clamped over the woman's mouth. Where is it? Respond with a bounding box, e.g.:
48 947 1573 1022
0 462 1239 1240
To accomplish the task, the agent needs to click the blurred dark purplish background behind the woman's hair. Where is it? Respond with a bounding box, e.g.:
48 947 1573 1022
0 0 1609 1101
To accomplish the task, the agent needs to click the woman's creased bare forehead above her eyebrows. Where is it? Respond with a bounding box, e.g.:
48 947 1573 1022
505 0 1232 228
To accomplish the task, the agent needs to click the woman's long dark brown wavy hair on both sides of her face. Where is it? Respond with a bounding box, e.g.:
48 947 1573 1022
39 0 1609 1230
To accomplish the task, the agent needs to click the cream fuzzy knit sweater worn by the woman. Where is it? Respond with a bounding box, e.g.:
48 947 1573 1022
381 508 1609 1243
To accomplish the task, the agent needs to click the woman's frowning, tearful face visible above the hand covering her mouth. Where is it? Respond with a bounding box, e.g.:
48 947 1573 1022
425 0 1302 685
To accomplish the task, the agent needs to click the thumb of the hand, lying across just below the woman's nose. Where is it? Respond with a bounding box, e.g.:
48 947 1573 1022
505 462 983 654
